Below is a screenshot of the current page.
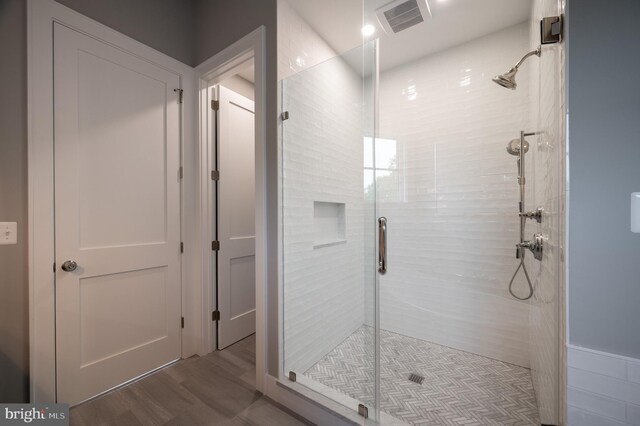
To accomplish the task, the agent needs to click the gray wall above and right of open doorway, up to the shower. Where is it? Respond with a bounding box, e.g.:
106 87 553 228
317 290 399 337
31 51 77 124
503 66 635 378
196 0 279 375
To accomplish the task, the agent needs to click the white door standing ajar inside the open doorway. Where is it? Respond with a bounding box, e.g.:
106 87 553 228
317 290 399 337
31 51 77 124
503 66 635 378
218 86 256 349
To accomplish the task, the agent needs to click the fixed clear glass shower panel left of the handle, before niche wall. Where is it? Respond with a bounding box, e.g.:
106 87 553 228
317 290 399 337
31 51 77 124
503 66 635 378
281 43 380 418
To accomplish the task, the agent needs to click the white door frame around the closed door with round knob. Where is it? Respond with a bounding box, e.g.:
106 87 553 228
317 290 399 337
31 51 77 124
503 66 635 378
27 0 198 402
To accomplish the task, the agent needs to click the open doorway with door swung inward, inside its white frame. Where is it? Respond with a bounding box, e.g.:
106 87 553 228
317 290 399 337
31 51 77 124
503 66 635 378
208 63 256 350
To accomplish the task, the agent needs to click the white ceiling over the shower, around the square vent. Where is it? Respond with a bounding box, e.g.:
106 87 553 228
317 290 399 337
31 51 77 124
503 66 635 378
288 0 532 71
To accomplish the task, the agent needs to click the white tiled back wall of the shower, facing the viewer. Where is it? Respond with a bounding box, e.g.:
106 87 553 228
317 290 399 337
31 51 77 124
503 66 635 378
378 23 532 367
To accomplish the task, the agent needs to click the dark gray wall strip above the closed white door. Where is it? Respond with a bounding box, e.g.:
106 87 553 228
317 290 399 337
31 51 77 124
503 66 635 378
56 0 196 66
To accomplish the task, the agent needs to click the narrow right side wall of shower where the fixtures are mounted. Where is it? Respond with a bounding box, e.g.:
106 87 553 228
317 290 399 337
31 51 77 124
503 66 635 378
524 0 565 424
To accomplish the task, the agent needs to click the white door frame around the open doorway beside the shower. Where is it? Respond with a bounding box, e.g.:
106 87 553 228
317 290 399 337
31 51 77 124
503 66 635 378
196 26 267 392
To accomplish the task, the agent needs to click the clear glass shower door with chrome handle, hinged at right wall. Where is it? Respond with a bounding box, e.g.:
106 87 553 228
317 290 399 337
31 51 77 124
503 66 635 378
364 0 563 425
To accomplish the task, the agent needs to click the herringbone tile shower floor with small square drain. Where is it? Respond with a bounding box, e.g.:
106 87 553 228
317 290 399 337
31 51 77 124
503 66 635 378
304 326 540 426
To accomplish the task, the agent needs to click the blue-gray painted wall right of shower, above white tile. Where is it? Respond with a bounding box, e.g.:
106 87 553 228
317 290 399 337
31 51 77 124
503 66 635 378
568 0 640 358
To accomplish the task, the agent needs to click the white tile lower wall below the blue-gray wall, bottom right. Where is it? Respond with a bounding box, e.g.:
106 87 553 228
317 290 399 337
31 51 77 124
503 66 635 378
567 345 640 426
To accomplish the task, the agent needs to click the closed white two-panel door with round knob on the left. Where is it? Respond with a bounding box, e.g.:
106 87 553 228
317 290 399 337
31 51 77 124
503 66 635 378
54 24 181 404
